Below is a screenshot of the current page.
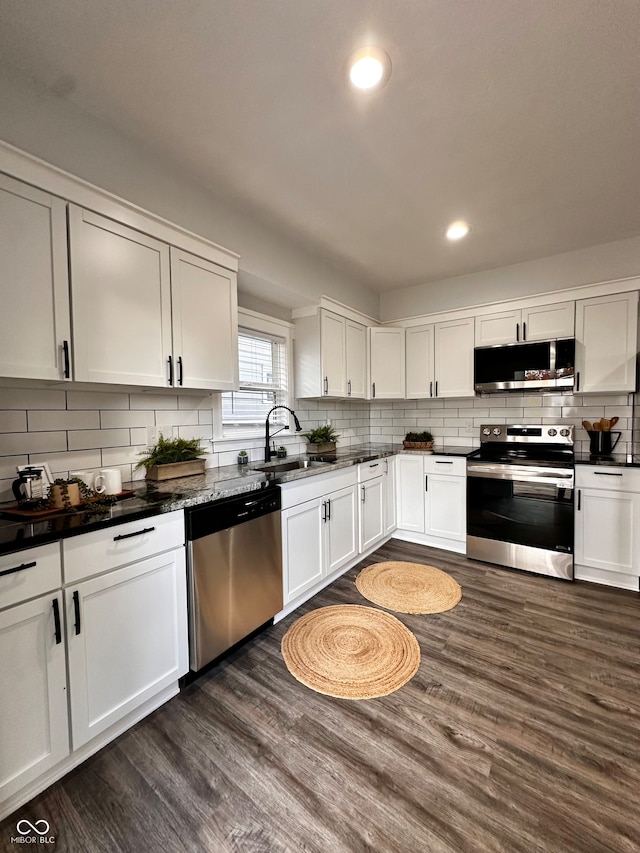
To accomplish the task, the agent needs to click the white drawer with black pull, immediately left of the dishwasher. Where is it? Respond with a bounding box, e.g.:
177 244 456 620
62 509 184 584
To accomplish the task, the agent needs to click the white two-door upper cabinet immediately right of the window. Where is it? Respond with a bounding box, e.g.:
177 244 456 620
294 308 367 399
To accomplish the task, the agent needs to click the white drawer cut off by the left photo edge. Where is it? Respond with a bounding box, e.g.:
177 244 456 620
0 542 62 608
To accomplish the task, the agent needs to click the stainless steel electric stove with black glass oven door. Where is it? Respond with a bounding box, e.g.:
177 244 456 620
467 424 574 580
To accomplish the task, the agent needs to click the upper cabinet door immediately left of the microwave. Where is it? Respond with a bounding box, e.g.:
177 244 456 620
434 319 475 397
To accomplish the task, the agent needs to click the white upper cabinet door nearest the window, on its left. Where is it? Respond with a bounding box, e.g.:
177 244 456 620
171 247 238 391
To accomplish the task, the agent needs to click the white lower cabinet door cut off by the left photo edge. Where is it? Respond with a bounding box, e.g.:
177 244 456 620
0 592 69 801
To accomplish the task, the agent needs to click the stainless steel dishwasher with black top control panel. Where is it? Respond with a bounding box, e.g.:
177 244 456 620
186 486 282 672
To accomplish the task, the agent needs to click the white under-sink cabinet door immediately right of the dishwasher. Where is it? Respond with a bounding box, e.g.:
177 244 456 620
281 498 325 604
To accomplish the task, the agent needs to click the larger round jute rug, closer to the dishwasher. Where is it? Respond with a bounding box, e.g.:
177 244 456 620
282 604 420 699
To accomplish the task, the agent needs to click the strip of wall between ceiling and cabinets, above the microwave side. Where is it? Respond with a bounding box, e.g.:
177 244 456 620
380 237 640 322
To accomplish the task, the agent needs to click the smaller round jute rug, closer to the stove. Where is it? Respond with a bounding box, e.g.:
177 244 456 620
356 562 462 613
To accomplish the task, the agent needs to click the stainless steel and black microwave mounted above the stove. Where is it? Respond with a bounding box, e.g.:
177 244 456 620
473 338 576 392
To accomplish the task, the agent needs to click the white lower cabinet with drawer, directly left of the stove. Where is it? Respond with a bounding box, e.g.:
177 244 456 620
396 453 467 553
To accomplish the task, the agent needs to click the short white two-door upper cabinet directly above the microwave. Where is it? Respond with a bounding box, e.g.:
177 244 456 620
475 302 575 347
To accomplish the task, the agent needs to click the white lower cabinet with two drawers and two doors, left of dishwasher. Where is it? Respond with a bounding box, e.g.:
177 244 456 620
0 510 188 819
